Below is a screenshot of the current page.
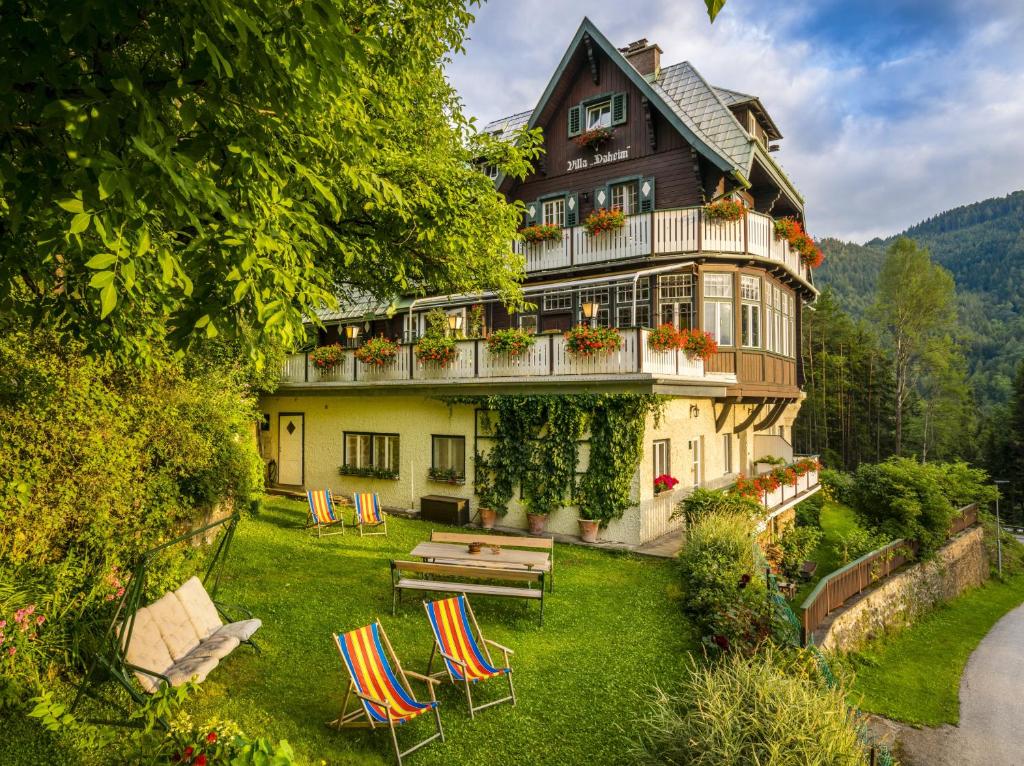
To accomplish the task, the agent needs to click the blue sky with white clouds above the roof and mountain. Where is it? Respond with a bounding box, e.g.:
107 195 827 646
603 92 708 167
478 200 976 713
449 0 1024 242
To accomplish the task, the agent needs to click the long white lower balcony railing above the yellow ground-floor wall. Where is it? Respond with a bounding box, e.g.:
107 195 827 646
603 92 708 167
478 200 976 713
281 329 736 387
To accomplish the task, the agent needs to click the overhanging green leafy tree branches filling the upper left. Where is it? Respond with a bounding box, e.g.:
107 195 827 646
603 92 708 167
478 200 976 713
0 0 538 357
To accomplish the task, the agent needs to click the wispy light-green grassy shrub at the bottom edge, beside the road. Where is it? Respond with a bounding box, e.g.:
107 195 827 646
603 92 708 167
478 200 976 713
637 649 868 766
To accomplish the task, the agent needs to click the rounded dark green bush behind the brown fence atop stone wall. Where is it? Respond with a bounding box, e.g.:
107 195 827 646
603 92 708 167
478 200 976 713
850 458 995 555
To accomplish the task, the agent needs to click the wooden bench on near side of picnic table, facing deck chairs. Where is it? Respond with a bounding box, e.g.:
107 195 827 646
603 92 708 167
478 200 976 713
391 561 544 625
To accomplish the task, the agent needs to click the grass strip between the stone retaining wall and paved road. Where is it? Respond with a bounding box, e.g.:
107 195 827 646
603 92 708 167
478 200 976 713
849 575 1024 726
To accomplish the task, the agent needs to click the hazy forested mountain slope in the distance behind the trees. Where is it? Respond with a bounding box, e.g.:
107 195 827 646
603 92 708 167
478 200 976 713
816 190 1024 410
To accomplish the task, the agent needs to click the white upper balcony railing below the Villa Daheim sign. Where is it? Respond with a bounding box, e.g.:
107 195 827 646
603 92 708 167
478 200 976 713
513 207 809 281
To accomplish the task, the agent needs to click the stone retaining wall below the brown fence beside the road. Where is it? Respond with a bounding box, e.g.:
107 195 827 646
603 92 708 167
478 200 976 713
814 526 988 652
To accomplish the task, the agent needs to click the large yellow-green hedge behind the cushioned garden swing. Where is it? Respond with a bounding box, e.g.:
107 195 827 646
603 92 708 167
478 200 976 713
0 333 262 698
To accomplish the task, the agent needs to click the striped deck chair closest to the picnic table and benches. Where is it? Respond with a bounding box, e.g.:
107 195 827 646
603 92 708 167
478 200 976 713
423 595 515 718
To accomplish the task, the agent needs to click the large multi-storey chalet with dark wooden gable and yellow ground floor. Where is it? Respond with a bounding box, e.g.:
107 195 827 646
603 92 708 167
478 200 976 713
261 19 816 545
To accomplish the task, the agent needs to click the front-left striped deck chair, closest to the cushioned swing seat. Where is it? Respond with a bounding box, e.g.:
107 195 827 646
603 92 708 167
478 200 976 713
328 623 444 766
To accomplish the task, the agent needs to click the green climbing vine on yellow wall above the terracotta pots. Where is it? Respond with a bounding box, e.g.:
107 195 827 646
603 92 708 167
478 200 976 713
441 393 663 526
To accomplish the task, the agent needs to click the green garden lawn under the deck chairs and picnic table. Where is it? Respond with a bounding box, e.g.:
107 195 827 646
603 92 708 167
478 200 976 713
0 499 697 766
